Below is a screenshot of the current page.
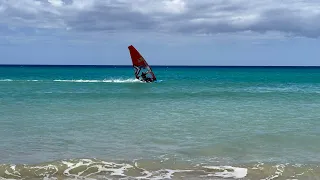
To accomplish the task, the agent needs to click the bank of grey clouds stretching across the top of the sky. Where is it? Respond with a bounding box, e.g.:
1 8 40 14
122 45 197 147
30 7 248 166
0 0 320 38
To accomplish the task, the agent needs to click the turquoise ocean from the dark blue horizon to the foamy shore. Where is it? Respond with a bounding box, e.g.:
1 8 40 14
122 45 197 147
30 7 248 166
0 66 320 180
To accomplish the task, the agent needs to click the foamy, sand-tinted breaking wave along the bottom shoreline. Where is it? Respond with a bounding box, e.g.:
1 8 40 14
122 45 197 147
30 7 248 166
0 159 320 180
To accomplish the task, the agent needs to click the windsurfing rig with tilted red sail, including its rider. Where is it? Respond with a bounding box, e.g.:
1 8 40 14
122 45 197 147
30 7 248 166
128 45 157 82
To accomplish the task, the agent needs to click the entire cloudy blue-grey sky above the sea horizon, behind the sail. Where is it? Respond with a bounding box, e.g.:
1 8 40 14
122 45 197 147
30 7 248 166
0 0 320 66
